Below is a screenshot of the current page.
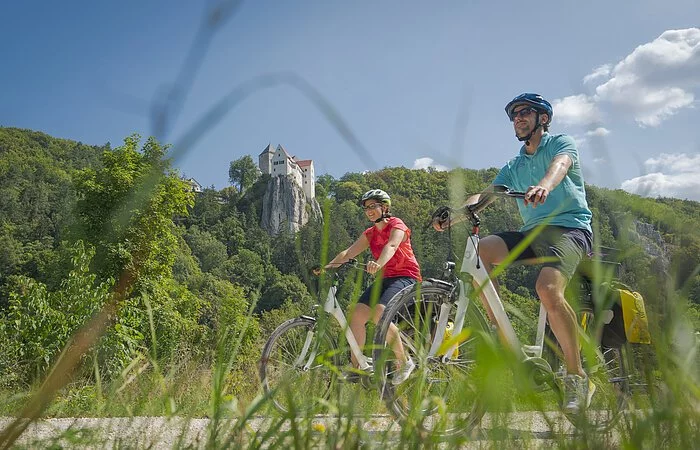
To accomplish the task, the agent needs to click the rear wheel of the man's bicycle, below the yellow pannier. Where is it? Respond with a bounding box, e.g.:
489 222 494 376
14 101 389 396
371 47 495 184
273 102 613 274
548 324 631 432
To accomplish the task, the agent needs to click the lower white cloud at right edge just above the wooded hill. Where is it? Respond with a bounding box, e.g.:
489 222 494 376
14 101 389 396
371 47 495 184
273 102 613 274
622 153 700 201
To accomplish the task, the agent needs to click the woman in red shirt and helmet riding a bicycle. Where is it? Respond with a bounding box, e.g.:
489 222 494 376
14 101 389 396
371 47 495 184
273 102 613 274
326 189 421 384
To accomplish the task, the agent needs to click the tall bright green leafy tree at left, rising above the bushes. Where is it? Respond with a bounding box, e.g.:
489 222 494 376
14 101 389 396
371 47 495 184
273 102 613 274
75 134 194 280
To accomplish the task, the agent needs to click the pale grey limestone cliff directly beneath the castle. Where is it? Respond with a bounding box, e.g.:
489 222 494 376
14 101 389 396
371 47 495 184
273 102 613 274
261 176 321 236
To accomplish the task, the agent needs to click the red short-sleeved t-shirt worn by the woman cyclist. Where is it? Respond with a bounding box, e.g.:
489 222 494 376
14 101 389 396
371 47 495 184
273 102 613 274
364 217 422 281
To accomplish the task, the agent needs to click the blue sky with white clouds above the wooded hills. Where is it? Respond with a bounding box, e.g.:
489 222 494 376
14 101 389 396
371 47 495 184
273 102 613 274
0 0 700 200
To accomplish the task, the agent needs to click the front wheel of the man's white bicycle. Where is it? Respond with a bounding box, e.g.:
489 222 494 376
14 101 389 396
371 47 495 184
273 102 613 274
374 281 487 436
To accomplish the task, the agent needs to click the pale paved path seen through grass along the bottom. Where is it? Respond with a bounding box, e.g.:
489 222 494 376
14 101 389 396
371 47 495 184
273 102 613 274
0 412 600 449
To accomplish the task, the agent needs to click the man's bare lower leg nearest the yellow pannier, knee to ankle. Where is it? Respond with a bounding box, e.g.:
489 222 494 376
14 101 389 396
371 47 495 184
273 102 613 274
535 267 586 377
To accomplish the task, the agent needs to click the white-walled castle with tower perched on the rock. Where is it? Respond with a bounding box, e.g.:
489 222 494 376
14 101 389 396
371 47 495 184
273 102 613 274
258 144 316 201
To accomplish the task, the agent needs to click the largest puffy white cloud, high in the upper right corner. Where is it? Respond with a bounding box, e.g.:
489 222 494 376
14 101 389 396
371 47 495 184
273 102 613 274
584 28 700 127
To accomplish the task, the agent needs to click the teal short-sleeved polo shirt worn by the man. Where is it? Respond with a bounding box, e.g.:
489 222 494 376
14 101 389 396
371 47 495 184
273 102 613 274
493 133 592 231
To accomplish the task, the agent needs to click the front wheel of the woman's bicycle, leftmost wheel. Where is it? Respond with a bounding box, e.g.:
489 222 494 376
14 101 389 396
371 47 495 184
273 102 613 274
260 317 337 413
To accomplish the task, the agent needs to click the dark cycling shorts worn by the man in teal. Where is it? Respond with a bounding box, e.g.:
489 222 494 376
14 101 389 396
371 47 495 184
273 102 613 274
495 226 593 280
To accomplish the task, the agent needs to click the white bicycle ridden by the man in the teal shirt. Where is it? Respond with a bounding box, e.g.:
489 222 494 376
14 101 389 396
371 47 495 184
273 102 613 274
373 189 630 436
